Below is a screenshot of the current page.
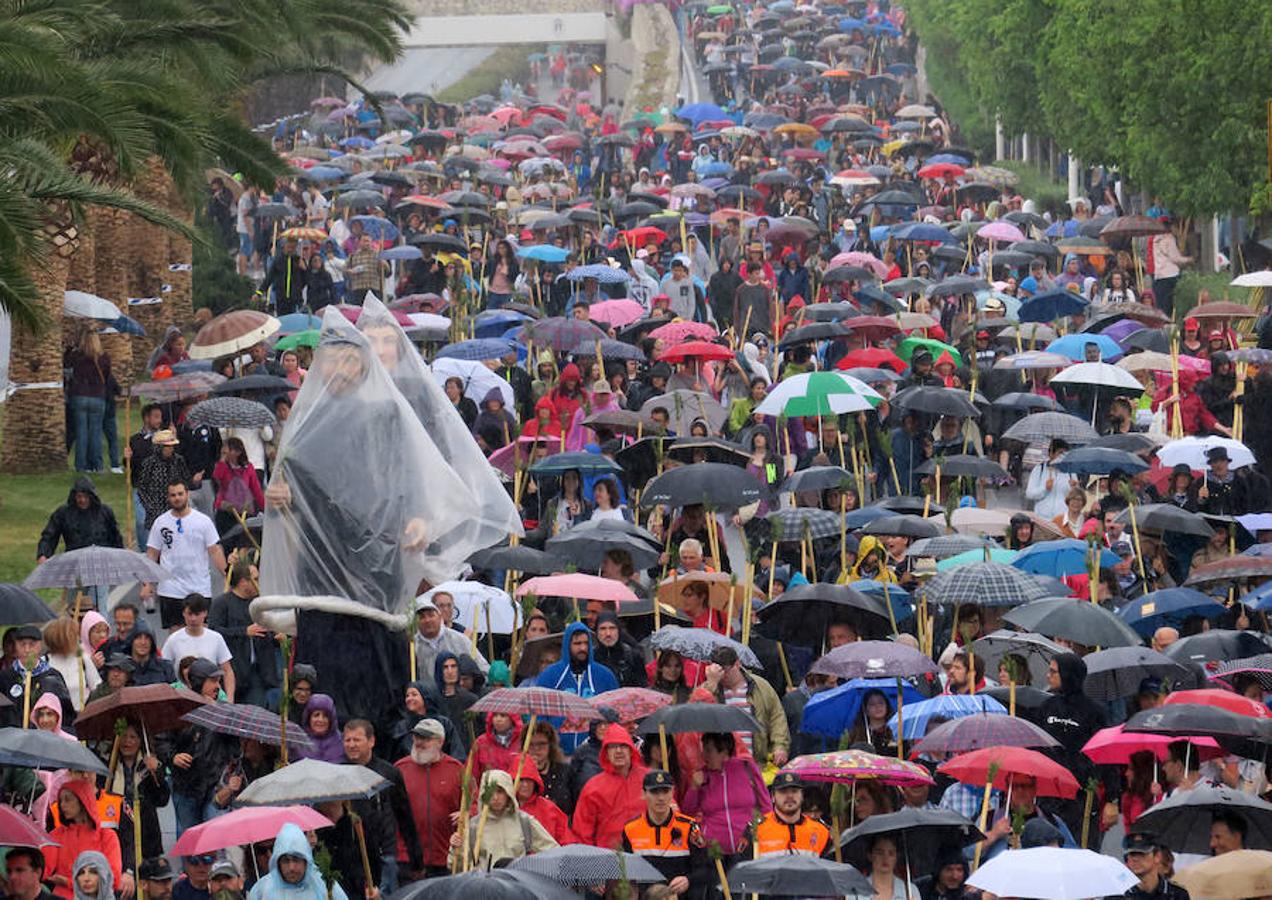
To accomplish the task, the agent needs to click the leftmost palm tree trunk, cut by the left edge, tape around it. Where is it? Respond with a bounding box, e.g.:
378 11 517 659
0 250 71 473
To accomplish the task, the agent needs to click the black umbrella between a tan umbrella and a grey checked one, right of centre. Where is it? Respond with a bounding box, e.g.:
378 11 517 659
759 583 892 651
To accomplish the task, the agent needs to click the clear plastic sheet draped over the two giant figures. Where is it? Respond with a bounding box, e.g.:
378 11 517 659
253 306 516 628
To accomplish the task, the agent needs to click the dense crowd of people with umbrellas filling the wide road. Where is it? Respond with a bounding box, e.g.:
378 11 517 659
14 0 1272 900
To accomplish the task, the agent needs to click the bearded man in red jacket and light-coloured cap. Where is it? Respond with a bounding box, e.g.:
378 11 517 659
394 718 464 877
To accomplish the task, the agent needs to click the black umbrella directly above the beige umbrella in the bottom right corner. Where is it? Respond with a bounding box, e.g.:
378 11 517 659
1135 784 1272 854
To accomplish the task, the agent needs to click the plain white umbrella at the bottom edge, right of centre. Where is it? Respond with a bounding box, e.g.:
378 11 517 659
967 847 1140 900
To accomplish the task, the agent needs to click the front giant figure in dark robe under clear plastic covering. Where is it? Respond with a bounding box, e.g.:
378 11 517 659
253 310 511 723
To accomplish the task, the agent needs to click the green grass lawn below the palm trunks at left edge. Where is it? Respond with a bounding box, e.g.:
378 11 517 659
0 404 141 587
